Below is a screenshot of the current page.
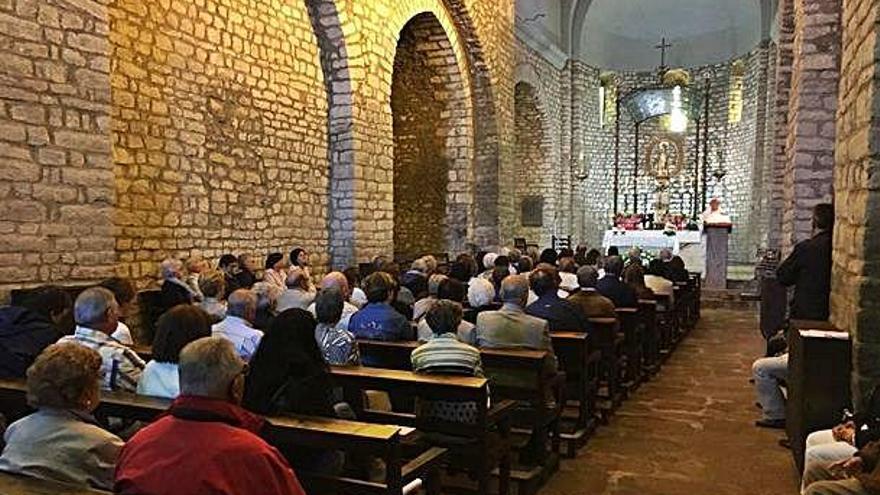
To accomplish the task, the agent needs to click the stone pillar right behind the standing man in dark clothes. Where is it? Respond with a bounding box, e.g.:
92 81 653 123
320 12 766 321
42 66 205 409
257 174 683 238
781 0 841 253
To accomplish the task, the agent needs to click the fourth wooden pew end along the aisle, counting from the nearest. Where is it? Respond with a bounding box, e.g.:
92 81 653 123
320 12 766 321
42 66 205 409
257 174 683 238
550 332 602 457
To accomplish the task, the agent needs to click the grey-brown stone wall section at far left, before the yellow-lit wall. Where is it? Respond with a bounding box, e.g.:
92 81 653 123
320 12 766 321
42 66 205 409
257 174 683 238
0 0 116 293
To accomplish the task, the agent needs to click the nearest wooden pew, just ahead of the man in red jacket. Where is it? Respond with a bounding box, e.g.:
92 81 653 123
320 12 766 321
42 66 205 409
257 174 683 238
0 380 446 495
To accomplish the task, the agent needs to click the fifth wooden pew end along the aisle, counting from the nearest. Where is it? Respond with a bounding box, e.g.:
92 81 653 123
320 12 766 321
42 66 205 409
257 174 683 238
589 318 625 423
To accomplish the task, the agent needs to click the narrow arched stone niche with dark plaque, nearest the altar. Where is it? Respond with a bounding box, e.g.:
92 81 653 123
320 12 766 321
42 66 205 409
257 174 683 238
514 81 555 246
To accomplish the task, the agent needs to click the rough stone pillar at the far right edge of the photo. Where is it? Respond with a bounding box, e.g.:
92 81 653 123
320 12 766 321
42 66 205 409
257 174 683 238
831 0 880 410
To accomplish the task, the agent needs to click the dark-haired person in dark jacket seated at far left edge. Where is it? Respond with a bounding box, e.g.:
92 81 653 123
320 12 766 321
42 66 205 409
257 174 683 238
0 285 73 378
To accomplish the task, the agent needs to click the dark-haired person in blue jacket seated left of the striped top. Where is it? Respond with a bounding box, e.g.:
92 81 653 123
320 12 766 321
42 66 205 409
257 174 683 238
348 271 412 341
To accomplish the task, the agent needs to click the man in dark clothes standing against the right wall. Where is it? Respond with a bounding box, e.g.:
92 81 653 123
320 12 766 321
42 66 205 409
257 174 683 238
776 203 834 321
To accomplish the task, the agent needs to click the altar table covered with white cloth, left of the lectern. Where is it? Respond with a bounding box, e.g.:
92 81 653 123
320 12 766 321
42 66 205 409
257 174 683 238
602 229 706 273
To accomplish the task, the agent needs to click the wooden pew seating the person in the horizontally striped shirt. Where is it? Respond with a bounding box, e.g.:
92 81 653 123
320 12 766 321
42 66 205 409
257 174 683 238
331 364 515 495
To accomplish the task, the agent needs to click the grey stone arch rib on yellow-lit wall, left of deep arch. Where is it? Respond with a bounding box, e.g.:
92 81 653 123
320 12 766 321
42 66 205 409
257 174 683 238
304 0 357 267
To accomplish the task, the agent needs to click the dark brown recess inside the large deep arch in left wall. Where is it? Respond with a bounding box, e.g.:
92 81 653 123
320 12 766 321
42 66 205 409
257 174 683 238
391 12 473 259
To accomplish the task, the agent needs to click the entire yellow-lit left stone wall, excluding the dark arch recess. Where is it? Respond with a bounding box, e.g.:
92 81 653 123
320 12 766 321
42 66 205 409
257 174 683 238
0 0 515 298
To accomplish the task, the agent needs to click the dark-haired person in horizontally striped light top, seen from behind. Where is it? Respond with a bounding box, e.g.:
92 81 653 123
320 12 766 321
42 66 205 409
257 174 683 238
410 300 483 421
